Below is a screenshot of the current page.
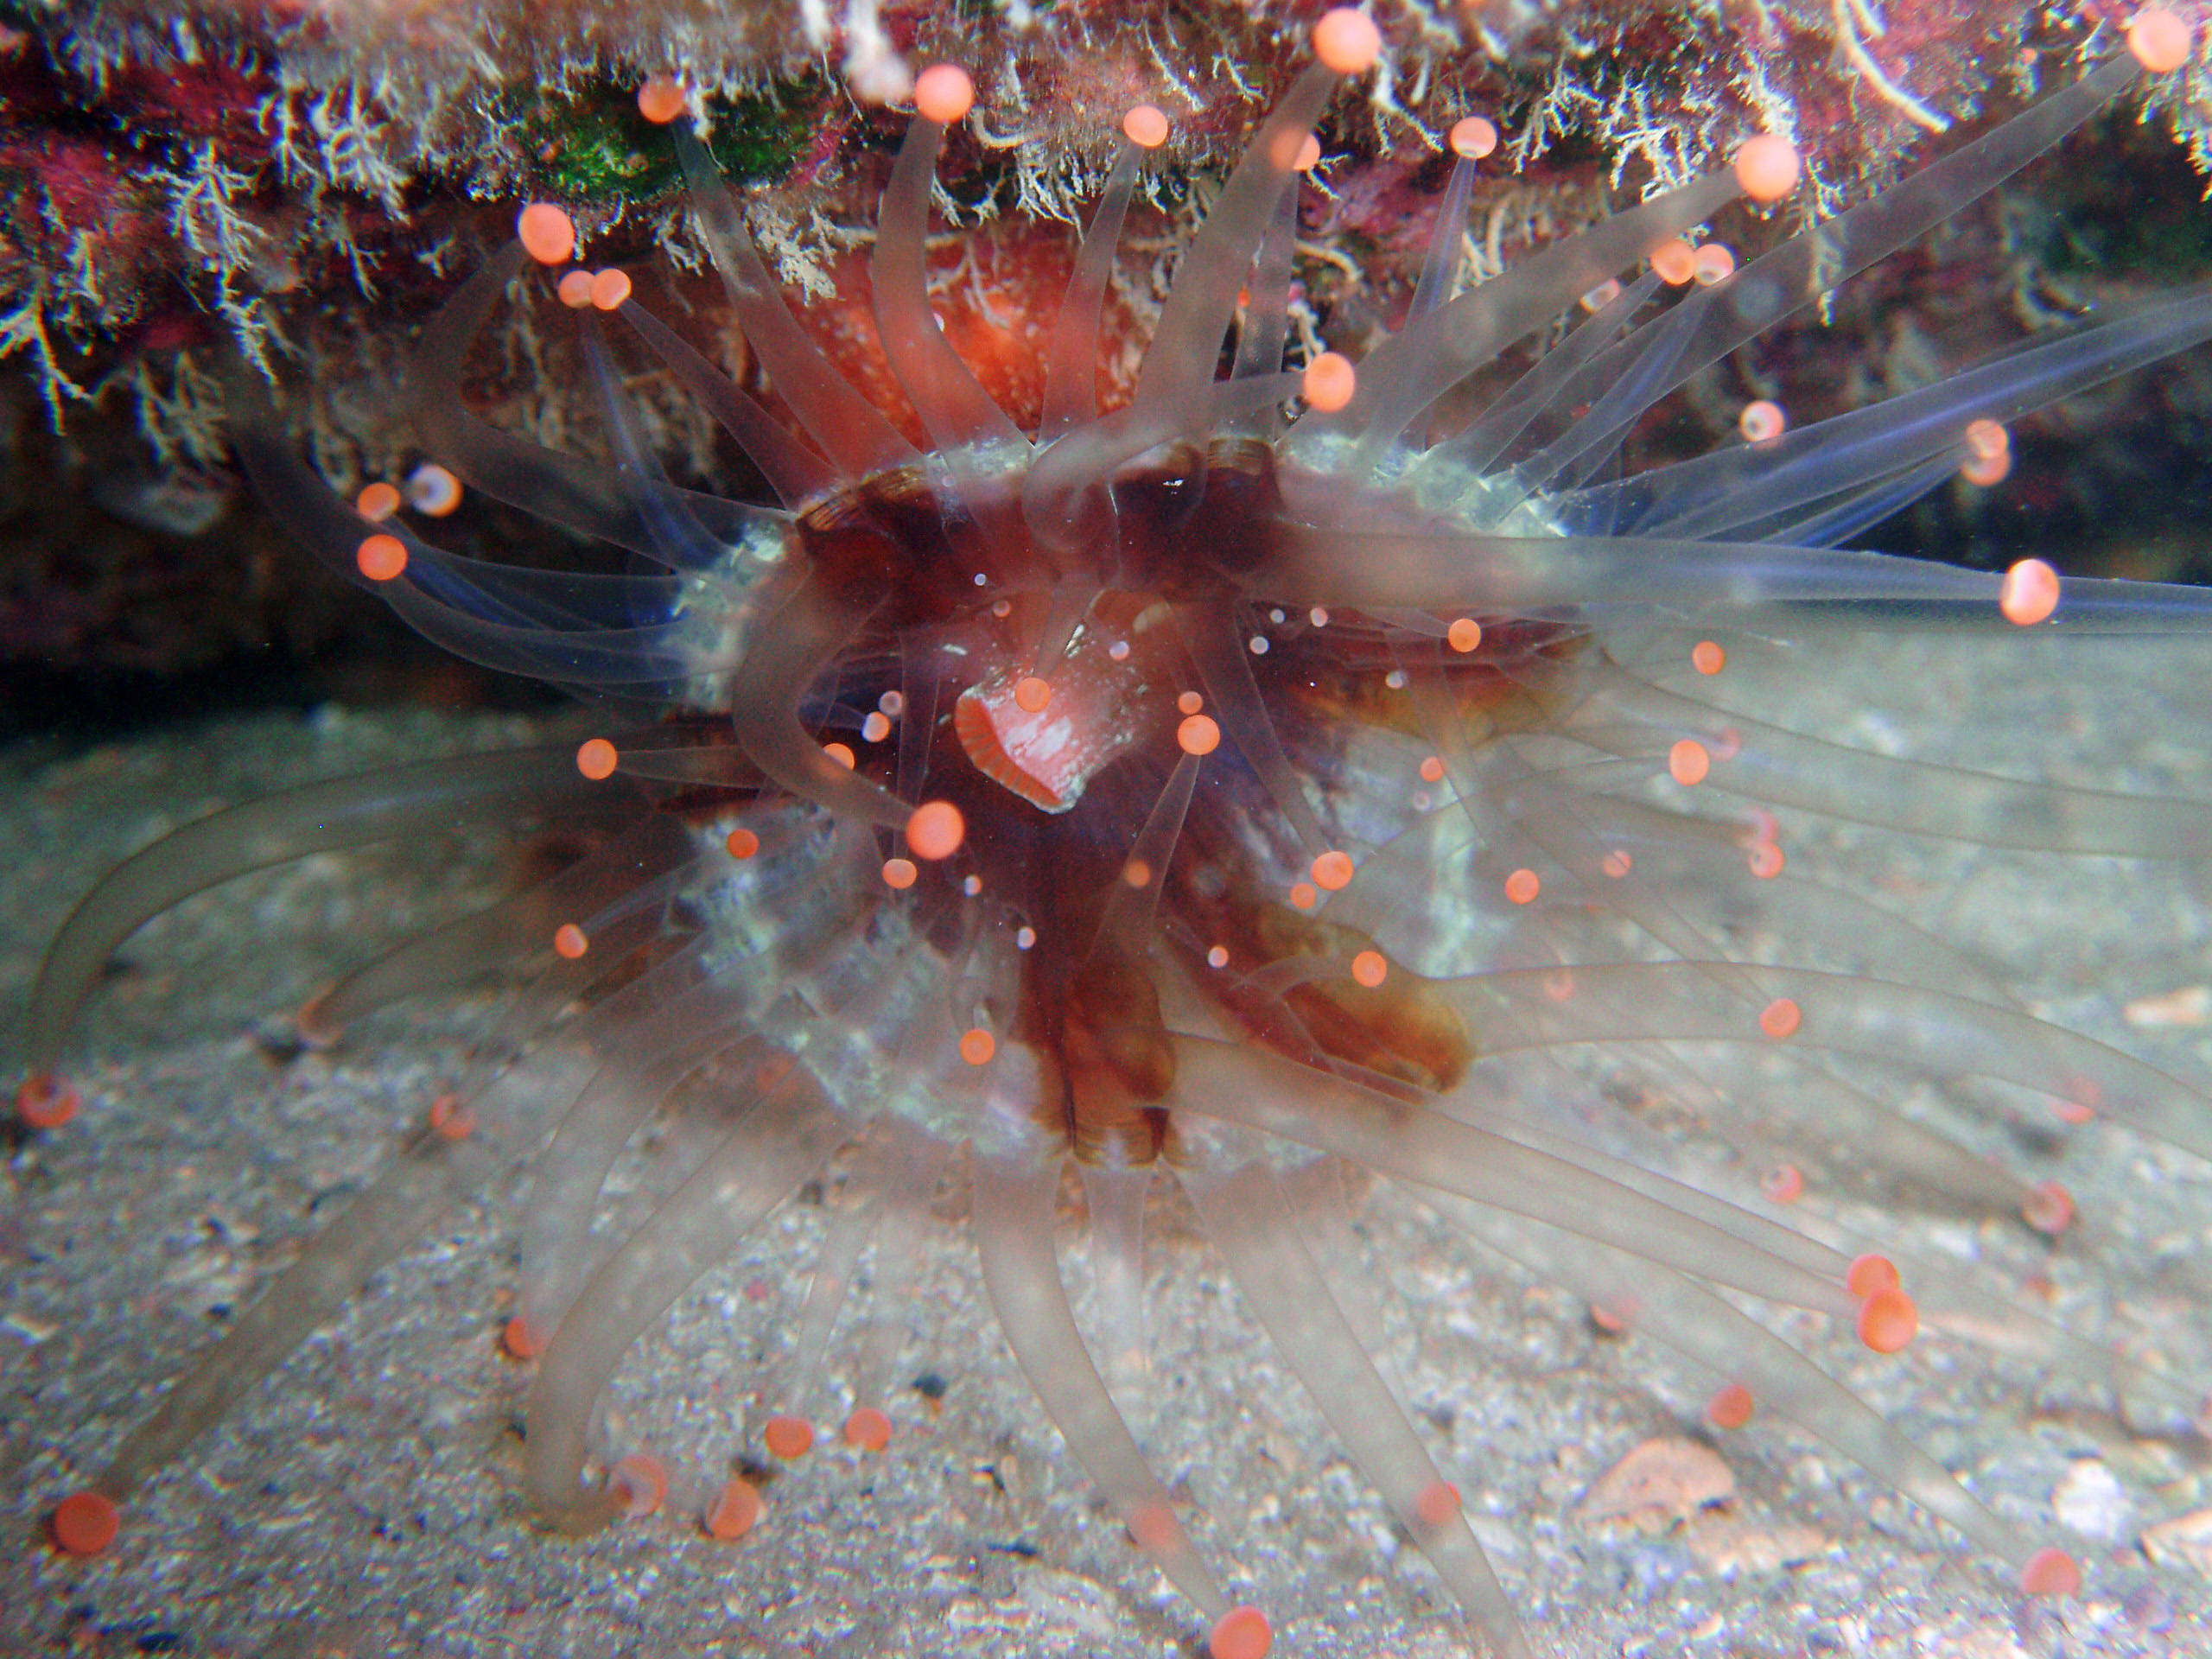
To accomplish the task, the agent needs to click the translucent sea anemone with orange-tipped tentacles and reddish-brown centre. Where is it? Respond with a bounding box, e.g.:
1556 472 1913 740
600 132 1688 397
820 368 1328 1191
20 9 2212 1659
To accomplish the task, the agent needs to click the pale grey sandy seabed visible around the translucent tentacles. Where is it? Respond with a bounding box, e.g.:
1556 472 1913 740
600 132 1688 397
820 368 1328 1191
0 639 2212 1659
